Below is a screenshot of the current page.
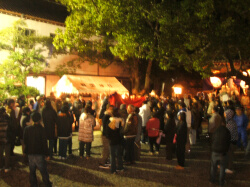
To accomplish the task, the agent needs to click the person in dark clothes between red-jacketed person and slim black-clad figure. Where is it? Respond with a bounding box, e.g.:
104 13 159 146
164 110 176 160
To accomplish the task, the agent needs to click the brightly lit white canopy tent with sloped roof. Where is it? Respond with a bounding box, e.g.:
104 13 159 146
52 75 129 96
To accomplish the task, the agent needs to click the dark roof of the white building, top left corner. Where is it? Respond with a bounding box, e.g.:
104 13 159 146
0 0 69 23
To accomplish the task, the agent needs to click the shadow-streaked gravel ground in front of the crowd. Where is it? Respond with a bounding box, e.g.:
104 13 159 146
0 129 250 187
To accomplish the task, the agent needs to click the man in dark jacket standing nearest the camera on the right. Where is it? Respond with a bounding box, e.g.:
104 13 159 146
210 122 231 186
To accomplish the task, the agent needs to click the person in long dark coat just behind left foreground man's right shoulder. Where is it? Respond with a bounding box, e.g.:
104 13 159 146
42 99 57 159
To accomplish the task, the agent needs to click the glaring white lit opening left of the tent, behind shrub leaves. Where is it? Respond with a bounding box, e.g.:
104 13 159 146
26 76 45 94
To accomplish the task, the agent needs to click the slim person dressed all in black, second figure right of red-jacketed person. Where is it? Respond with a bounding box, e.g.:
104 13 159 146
175 112 187 169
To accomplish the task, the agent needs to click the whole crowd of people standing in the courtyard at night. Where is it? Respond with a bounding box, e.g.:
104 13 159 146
0 90 249 186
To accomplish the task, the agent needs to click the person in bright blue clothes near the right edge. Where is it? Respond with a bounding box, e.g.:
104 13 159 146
234 105 248 149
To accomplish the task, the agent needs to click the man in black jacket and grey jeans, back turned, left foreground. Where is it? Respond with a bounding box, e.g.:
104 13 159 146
23 112 52 187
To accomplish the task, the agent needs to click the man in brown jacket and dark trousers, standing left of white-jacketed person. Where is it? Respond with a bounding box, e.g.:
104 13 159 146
123 105 138 164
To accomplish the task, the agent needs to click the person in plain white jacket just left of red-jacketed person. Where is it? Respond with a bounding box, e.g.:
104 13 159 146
139 101 151 143
